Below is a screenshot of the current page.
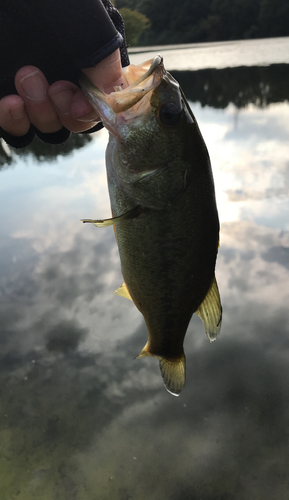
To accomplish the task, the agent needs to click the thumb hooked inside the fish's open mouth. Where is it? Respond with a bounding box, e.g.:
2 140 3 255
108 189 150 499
82 49 128 94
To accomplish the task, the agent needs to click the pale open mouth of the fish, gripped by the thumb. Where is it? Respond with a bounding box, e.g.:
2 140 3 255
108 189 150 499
79 55 165 115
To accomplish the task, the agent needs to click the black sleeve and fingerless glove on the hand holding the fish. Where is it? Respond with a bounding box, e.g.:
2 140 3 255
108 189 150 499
0 0 129 147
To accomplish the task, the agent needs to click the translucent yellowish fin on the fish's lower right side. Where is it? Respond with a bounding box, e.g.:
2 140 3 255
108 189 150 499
196 276 222 342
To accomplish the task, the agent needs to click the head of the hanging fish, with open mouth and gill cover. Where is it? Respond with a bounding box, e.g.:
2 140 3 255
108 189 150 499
80 55 206 209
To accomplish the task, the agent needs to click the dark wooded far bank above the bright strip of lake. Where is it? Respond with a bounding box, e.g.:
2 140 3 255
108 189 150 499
115 0 289 45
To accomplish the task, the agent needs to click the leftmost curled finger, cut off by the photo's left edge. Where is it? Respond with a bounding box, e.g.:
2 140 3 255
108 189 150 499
0 95 30 136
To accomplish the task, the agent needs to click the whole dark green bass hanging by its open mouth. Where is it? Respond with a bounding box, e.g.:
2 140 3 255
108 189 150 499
80 55 222 396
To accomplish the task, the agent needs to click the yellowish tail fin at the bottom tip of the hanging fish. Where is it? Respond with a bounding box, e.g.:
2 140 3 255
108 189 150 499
137 344 186 396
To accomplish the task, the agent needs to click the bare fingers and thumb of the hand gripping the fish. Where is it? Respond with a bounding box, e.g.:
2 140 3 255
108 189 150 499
0 50 127 136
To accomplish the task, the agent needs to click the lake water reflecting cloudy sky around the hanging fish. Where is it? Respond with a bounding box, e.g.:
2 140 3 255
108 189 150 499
0 38 289 500
